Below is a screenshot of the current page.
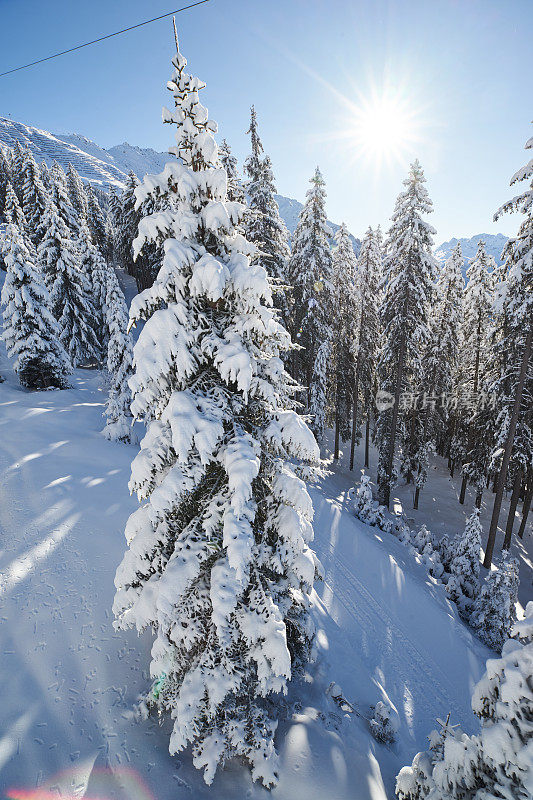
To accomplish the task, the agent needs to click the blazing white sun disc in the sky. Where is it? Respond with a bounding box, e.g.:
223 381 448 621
351 93 419 165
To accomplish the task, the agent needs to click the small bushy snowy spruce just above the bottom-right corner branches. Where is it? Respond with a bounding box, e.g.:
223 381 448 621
470 550 519 652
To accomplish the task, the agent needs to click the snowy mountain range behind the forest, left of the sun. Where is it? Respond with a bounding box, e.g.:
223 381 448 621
0 116 361 248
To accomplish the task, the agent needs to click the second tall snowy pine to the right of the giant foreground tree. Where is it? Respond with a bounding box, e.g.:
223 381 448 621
288 167 331 413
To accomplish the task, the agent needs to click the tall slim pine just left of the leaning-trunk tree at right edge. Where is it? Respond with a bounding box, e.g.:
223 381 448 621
459 241 496 505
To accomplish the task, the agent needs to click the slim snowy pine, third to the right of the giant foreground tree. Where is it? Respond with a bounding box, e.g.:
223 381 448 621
329 223 359 459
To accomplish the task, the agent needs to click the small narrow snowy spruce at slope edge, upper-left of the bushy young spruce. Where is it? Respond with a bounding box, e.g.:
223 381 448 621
446 508 482 613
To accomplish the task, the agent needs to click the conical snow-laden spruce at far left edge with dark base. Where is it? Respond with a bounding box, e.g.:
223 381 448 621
1 186 72 389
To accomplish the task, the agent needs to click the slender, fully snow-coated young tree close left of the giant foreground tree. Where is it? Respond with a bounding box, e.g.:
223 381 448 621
102 272 137 444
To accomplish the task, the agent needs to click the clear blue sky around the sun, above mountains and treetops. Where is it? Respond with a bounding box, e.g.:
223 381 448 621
0 0 533 243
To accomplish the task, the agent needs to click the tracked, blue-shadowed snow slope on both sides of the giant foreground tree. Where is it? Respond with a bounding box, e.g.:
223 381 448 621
0 334 498 800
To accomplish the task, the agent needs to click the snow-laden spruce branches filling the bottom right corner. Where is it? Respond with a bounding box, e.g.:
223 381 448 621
396 603 533 800
